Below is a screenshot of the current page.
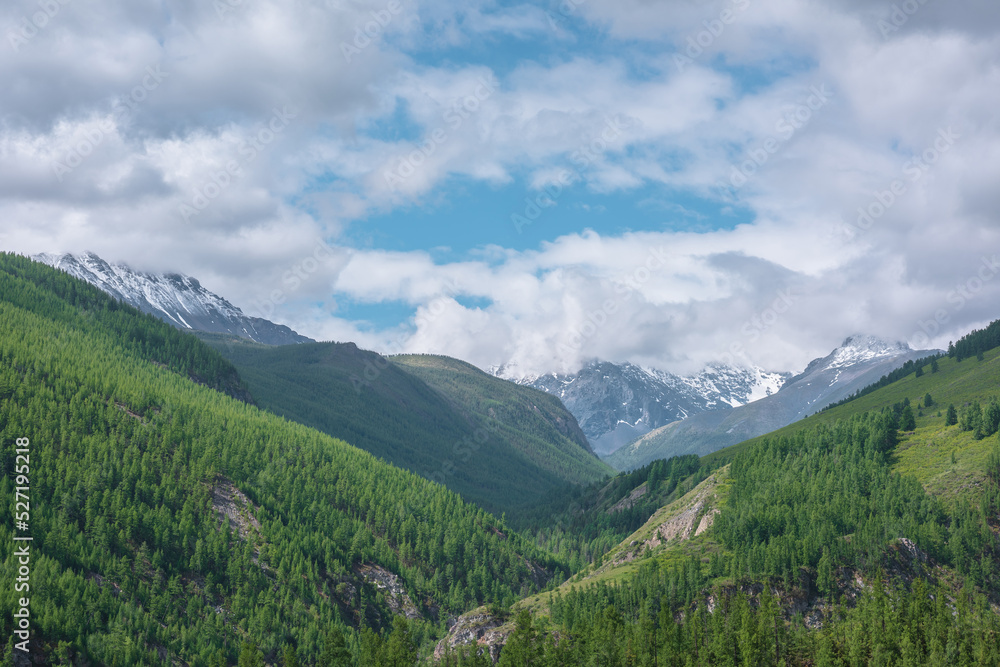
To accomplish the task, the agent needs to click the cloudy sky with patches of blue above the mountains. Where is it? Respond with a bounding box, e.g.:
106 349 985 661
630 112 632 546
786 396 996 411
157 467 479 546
0 0 1000 373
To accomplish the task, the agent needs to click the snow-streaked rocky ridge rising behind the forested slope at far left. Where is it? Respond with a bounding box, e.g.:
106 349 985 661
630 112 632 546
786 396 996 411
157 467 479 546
32 252 313 345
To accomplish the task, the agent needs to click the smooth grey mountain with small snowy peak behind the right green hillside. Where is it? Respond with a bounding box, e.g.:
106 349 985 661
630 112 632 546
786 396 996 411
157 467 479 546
606 335 940 470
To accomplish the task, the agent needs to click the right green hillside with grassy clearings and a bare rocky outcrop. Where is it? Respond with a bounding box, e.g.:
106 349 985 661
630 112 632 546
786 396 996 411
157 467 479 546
444 326 1000 667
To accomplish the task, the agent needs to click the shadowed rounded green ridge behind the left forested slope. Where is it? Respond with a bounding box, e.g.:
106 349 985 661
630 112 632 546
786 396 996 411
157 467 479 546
206 336 613 519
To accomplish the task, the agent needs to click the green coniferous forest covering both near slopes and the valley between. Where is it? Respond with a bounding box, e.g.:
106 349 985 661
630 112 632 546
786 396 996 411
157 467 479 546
0 255 1000 667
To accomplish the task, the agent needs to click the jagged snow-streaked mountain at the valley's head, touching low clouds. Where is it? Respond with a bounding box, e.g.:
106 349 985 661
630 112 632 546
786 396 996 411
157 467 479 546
490 361 789 455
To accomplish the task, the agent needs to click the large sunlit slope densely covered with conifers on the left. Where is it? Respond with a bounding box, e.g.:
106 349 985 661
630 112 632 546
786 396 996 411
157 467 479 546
0 255 565 665
